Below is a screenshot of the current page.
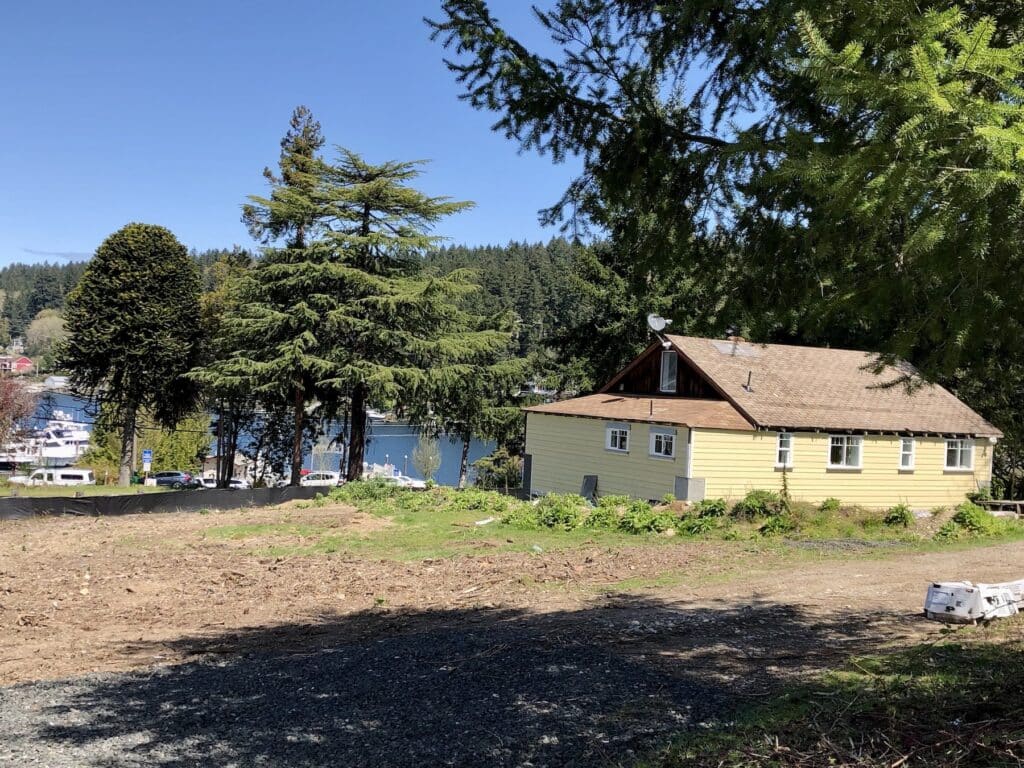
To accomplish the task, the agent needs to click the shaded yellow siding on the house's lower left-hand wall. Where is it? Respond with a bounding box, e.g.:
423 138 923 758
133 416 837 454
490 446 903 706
526 413 687 499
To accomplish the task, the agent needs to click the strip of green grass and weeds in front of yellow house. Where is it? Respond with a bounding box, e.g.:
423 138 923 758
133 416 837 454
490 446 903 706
195 483 1024 565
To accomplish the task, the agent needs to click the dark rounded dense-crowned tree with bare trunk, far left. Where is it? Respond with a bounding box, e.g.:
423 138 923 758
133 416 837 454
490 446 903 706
59 223 201 485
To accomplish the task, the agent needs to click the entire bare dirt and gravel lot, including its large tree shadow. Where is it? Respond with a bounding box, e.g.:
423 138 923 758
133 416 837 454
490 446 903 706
0 507 1024 766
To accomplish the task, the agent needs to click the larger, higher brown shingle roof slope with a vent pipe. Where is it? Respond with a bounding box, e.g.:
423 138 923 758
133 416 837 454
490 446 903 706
668 336 1002 437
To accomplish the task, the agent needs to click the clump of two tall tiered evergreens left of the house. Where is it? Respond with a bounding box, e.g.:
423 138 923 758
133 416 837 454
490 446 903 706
211 112 508 483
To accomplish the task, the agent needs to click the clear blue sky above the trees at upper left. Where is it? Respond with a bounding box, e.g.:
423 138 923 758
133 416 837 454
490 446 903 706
0 0 575 264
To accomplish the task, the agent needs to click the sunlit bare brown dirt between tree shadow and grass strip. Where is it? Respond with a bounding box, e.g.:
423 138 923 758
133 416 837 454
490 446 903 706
0 507 1024 686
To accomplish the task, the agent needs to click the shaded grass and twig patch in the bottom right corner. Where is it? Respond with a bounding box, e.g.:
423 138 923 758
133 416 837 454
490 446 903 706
642 618 1024 768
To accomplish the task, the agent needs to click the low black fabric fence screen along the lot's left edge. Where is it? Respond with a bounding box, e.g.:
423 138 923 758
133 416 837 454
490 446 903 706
0 486 330 520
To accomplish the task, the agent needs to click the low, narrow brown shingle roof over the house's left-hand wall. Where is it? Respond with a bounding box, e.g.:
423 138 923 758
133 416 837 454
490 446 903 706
523 394 754 430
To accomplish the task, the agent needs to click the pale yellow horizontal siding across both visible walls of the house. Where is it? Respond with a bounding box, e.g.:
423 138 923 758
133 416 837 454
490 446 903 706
526 413 993 509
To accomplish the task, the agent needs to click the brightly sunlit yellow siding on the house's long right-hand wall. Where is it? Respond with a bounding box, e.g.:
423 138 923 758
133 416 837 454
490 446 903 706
692 429 993 509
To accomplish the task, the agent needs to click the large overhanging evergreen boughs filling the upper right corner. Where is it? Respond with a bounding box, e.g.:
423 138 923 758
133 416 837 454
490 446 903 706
431 0 1024 377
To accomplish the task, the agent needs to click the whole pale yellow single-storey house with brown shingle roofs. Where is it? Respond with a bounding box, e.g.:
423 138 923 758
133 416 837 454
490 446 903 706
525 336 1002 509
